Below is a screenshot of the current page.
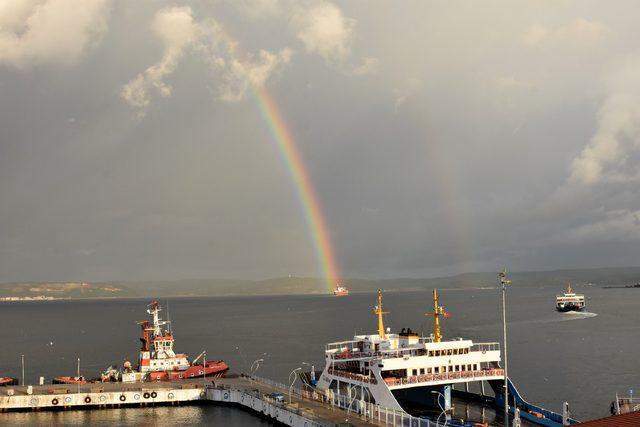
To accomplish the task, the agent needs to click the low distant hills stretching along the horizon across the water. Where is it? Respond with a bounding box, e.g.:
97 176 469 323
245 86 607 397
0 267 640 298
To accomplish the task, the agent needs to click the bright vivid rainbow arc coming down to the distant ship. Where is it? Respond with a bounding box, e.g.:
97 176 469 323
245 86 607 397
252 85 340 292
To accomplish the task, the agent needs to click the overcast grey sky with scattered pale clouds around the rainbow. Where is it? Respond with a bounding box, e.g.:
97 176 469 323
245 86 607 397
0 0 640 281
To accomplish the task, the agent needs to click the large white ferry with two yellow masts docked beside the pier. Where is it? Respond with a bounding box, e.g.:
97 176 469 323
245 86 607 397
310 289 575 426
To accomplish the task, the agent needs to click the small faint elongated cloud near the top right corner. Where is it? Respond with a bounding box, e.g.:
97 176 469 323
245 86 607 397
522 18 606 47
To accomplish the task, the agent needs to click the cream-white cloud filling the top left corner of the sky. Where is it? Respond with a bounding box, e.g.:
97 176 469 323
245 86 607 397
0 0 109 68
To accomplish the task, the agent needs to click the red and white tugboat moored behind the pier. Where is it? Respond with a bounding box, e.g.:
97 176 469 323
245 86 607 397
134 301 229 381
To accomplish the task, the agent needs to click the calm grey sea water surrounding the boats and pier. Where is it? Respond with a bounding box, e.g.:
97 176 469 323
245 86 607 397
0 286 640 426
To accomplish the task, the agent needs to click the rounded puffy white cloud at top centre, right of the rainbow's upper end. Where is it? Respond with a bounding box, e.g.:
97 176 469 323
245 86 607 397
290 1 355 64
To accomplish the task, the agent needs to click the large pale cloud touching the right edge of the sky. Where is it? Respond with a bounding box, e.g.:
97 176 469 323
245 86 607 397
569 56 640 185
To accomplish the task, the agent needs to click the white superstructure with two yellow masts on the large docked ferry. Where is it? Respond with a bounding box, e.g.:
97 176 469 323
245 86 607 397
316 290 504 409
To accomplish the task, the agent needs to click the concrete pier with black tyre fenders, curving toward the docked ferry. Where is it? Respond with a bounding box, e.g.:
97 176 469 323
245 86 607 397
0 376 439 427
